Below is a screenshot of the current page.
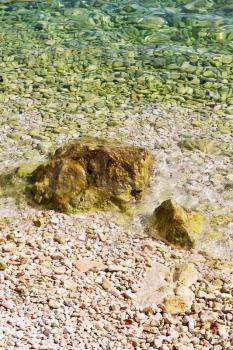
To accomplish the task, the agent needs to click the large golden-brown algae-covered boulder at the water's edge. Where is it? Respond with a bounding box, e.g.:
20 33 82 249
31 139 153 212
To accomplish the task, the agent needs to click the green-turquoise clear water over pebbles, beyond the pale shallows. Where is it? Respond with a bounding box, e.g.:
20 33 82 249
0 0 233 111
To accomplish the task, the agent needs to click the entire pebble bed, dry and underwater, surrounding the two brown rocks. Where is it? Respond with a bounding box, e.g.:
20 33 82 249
0 0 233 350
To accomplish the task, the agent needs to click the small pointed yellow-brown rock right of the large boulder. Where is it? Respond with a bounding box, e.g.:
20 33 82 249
151 199 204 248
